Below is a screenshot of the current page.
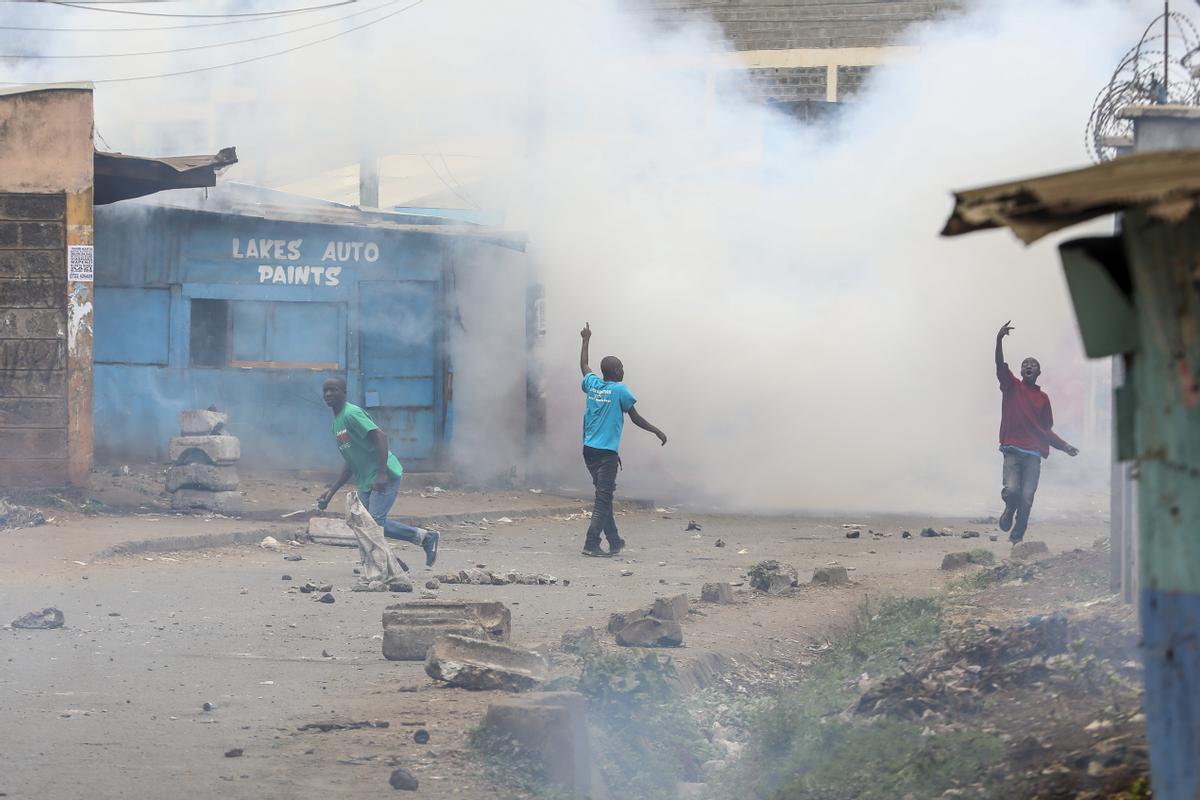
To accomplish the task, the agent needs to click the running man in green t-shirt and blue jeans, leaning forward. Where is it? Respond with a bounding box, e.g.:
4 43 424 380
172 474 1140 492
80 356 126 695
317 378 439 566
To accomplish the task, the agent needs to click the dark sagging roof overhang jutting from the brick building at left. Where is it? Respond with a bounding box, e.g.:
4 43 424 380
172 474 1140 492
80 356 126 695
94 148 238 205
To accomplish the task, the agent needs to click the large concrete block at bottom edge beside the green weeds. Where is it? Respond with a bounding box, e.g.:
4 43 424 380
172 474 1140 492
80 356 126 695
481 692 590 799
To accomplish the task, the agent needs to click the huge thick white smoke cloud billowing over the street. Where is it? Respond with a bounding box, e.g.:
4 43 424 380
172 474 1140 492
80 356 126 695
7 0 1157 512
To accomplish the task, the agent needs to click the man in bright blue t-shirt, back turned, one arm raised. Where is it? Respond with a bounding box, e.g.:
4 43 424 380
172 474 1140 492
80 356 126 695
580 325 667 557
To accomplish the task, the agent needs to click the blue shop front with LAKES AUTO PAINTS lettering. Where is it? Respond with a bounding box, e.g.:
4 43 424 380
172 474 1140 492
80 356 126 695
94 194 524 470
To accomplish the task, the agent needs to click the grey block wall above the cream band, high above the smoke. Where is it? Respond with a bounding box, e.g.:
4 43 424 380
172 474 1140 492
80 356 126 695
630 0 960 50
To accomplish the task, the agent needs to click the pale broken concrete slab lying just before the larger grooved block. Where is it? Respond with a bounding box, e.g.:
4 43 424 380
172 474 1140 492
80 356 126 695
425 634 550 692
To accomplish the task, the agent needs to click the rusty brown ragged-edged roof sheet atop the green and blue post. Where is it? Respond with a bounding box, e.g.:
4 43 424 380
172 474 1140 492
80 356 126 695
942 150 1200 243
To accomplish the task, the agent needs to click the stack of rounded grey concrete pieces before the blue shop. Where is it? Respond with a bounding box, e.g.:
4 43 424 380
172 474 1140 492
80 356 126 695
167 409 241 513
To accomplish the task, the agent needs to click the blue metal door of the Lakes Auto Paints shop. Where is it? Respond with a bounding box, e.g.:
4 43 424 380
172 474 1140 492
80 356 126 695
359 281 443 469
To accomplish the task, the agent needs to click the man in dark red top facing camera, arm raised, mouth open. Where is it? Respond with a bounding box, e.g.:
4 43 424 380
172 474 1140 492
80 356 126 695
996 320 1079 545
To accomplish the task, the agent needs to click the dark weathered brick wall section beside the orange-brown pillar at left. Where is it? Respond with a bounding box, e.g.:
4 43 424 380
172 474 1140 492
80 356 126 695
0 193 67 489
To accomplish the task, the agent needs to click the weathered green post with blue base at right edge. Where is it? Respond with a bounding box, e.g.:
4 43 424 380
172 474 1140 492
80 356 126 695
1099 207 1200 800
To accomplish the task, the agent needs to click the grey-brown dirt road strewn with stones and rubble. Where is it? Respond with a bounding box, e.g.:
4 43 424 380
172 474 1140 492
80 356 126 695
0 512 1104 799
